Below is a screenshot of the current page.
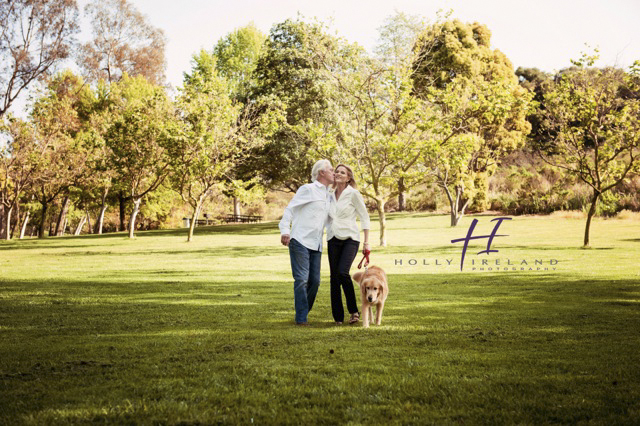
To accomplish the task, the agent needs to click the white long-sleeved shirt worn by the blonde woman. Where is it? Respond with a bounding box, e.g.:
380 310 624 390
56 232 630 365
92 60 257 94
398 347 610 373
327 185 370 241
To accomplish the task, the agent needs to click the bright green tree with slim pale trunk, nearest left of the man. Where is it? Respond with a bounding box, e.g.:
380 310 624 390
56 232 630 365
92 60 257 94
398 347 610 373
170 51 268 241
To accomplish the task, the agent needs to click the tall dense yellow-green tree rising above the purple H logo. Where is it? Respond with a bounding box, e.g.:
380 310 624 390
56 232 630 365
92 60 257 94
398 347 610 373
412 20 532 226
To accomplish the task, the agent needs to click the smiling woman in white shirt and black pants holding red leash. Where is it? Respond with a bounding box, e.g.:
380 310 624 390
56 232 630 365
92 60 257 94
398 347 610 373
327 164 369 325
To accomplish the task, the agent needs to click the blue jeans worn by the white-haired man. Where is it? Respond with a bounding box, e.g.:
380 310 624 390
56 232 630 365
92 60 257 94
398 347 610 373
289 239 322 323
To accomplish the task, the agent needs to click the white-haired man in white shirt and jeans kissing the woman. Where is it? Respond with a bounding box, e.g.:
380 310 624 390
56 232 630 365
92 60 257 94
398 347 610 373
279 160 333 325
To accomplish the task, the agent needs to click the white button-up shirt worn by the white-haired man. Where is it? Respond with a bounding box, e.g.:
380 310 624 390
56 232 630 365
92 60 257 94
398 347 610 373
278 181 331 251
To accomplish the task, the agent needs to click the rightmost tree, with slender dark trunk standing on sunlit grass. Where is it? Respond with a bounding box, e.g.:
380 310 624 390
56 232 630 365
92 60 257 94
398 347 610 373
538 55 640 247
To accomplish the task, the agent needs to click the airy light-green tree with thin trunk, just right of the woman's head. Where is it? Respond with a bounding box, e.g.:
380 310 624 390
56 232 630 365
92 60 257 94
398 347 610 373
308 19 432 246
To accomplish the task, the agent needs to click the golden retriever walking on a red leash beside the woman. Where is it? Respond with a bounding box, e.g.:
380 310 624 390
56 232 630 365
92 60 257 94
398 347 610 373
353 266 389 327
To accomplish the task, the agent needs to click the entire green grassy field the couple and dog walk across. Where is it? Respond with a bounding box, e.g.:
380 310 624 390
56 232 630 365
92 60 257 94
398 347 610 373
0 214 640 425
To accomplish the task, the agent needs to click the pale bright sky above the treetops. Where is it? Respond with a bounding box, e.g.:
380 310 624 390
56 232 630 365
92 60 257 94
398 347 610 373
6 0 640 115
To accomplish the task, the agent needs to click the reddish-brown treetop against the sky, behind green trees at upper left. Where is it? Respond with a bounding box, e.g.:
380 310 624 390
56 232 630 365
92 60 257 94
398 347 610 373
78 0 166 84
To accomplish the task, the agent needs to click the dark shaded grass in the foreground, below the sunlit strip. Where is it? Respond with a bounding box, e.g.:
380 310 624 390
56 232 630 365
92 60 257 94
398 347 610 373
0 265 640 424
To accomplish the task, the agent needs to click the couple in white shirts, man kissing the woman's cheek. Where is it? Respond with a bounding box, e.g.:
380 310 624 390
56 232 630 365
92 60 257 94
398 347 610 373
279 160 369 325
